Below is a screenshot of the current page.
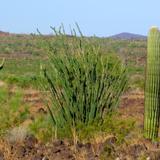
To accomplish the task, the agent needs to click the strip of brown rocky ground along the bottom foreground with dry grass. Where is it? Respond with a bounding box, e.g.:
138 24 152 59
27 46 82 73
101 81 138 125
0 136 160 160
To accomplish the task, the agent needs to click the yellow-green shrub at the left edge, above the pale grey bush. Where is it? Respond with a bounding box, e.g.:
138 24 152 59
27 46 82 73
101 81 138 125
0 87 29 136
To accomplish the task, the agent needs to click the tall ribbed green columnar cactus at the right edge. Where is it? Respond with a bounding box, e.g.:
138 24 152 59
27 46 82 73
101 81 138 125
144 27 160 140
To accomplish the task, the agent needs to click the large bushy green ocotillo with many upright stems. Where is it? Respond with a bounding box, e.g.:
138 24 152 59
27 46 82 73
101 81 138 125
41 26 127 139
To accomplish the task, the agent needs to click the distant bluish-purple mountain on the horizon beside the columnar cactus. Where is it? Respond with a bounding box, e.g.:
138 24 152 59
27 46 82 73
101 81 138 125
108 32 147 40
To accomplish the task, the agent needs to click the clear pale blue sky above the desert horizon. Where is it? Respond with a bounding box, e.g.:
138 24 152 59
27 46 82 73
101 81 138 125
0 0 160 36
